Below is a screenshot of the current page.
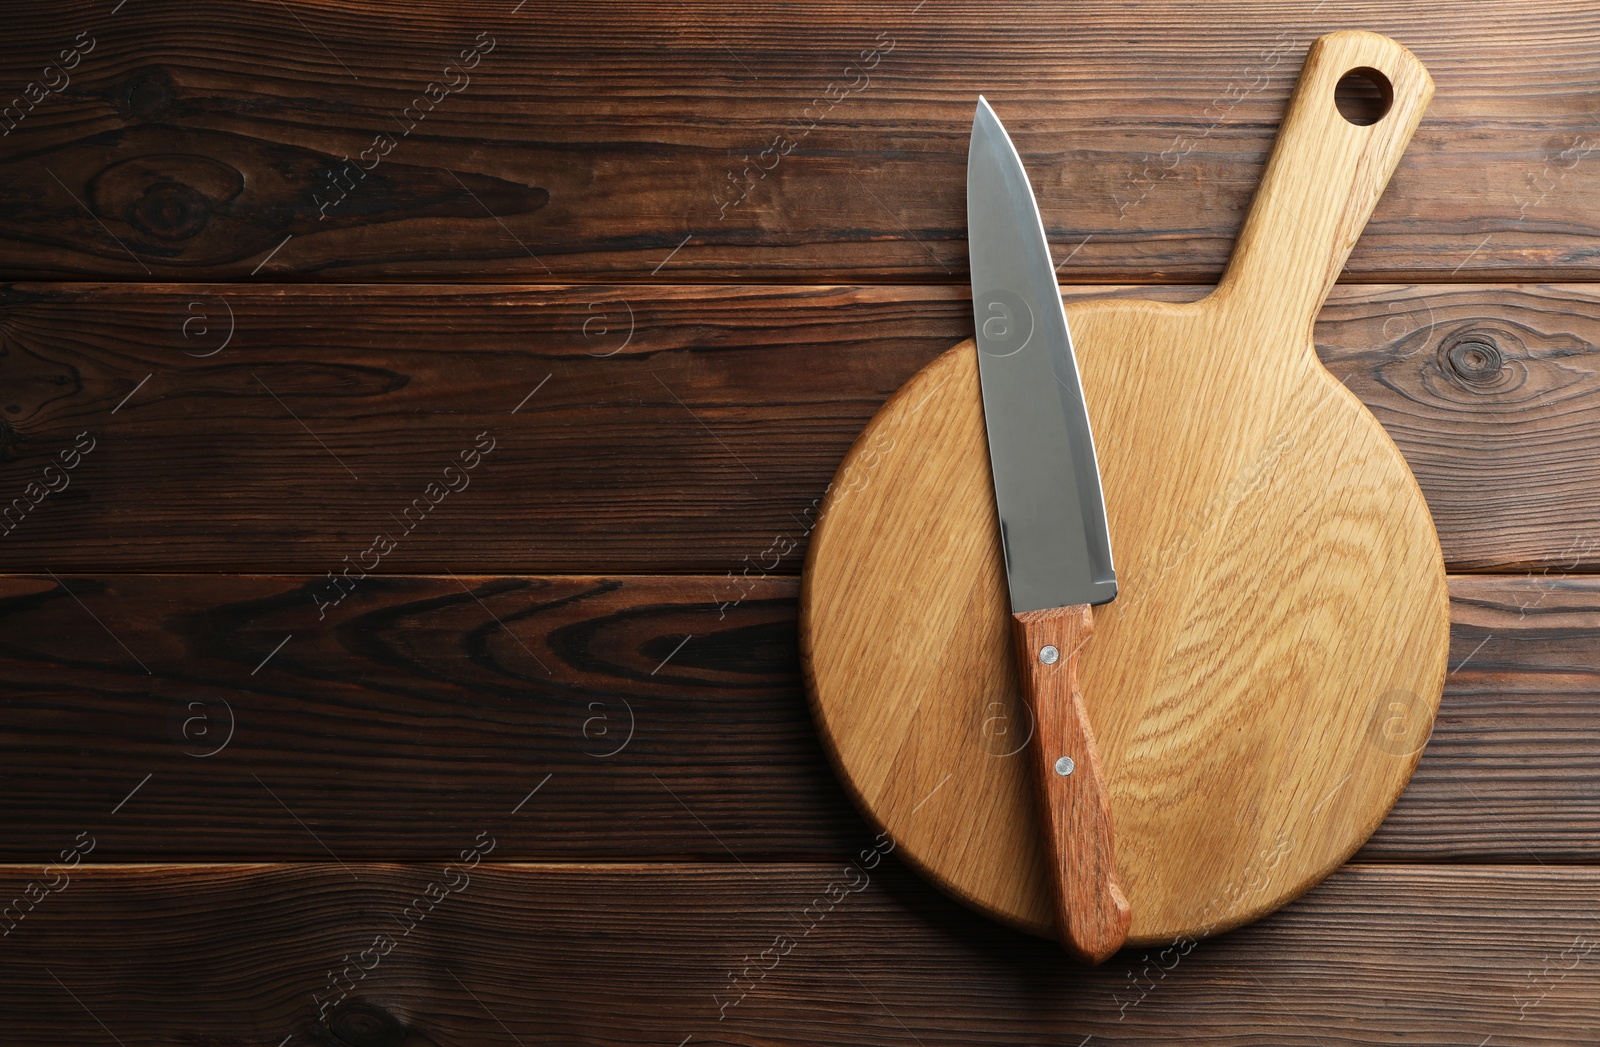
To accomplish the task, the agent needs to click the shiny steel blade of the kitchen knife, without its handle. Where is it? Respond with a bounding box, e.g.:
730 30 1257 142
966 98 1117 613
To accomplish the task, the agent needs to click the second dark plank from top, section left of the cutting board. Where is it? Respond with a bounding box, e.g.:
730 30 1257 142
0 285 965 573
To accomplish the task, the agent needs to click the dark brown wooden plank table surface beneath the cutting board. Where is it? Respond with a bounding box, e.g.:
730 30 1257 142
0 0 1600 1047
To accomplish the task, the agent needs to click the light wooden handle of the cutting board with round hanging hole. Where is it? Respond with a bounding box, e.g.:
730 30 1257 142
1214 30 1434 340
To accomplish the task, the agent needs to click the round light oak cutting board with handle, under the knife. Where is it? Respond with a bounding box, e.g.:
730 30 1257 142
802 32 1450 945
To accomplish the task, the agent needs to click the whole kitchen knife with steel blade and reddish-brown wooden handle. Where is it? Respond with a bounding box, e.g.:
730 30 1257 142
966 96 1131 964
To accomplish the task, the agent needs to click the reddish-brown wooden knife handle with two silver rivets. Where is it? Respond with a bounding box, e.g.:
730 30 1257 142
1011 604 1133 964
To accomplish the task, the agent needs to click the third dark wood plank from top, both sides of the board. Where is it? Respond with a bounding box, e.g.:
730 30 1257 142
0 575 1600 863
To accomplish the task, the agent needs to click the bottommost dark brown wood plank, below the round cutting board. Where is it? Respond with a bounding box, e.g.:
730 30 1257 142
0 864 1600 1047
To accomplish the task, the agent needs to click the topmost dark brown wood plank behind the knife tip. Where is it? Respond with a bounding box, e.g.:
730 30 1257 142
0 0 1600 282
